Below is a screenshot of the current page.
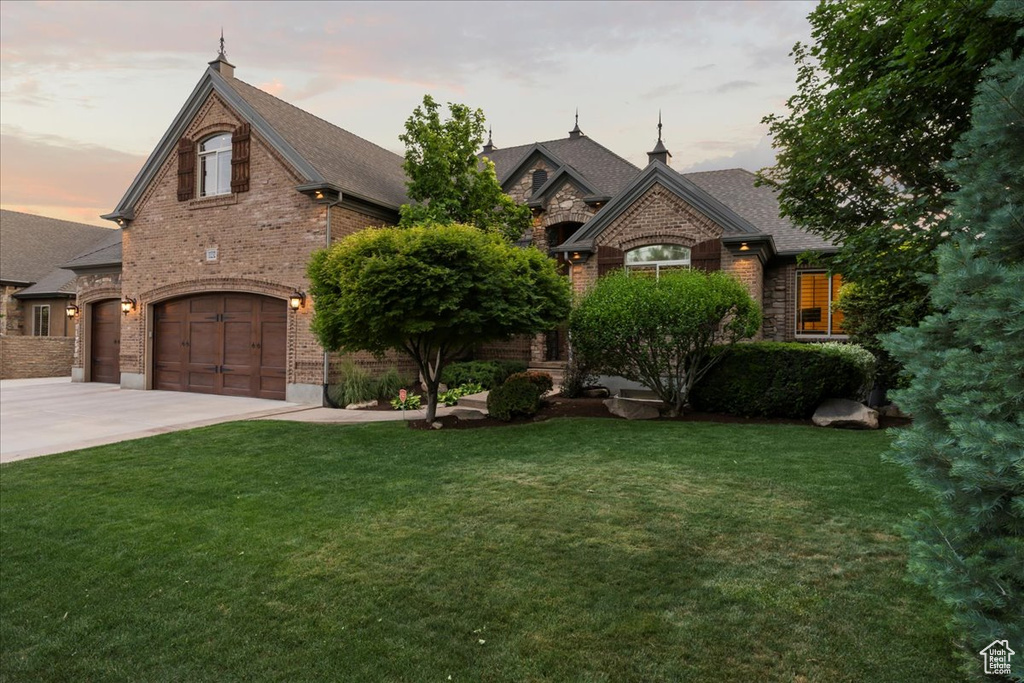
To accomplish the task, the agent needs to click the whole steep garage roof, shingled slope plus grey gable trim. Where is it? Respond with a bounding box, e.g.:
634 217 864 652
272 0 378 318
103 61 408 220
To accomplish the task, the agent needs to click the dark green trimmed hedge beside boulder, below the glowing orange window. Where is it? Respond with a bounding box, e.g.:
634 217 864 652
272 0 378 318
690 342 867 418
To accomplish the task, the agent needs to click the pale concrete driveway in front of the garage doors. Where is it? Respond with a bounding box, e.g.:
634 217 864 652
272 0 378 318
0 378 309 463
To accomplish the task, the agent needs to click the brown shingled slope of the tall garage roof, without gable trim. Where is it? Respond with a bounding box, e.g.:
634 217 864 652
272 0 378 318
224 78 409 209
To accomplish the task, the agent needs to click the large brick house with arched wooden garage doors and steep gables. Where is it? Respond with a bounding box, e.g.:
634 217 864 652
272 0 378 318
69 53 835 404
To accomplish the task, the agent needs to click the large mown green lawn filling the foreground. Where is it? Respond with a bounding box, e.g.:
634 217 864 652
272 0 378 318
0 420 956 682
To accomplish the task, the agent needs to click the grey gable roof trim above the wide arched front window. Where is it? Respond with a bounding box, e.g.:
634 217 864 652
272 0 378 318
558 161 765 251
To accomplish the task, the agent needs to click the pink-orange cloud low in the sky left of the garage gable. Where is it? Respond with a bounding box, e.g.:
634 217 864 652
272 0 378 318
0 126 145 224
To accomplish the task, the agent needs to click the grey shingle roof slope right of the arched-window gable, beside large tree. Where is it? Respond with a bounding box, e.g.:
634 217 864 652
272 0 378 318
680 168 837 254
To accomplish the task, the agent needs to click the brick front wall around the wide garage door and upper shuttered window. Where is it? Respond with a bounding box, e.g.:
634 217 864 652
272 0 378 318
104 94 383 401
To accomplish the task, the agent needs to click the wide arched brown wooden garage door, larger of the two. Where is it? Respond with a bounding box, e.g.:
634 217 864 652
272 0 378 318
153 293 288 400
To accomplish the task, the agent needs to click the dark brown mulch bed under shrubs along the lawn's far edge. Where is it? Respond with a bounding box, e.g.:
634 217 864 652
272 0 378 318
403 396 910 429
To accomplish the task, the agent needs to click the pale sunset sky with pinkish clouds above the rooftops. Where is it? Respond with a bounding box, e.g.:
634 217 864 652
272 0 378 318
0 0 814 226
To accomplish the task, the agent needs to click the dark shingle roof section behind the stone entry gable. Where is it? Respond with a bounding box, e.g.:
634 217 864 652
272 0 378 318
483 136 640 195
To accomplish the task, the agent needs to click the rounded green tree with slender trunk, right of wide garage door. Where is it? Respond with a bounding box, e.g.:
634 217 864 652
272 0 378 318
308 224 569 421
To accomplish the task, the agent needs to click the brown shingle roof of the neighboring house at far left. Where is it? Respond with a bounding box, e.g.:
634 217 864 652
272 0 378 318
0 210 120 284
